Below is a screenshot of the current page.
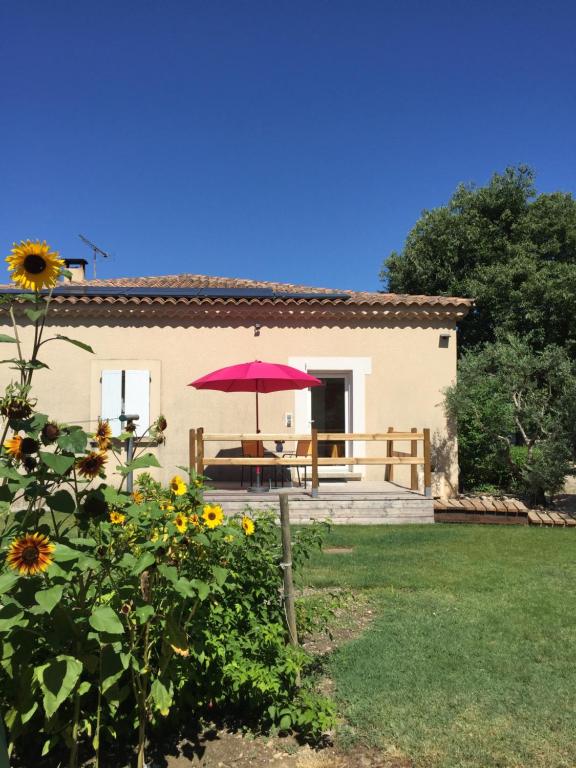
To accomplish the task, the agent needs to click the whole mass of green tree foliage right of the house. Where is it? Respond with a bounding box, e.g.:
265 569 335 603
381 166 576 502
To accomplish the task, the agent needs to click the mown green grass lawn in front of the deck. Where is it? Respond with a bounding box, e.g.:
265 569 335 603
304 525 576 768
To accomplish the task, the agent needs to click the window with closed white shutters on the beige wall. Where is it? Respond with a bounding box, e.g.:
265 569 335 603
100 370 150 437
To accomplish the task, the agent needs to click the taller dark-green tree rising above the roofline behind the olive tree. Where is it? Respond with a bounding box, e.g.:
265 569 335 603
381 166 576 357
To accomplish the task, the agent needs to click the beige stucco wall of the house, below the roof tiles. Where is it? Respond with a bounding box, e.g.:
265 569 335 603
0 319 457 494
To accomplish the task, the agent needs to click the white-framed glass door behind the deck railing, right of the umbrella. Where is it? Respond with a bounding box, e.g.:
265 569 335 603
308 371 353 475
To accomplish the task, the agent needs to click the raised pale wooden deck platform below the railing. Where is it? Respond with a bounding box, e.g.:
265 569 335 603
205 480 434 525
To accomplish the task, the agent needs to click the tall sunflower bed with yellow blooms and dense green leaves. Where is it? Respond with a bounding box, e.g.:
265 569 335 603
0 241 333 768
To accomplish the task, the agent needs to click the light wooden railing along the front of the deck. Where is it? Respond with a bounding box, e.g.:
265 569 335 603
189 427 432 496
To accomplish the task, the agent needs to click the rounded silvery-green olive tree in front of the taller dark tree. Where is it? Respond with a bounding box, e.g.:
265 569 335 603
446 336 576 504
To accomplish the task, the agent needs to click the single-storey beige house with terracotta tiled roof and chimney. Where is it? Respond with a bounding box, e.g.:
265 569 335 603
0 259 472 495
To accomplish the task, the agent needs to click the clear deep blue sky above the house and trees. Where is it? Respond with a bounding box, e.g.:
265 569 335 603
0 0 576 290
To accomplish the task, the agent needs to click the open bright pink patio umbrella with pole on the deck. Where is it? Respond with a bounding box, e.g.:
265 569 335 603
188 360 322 488
